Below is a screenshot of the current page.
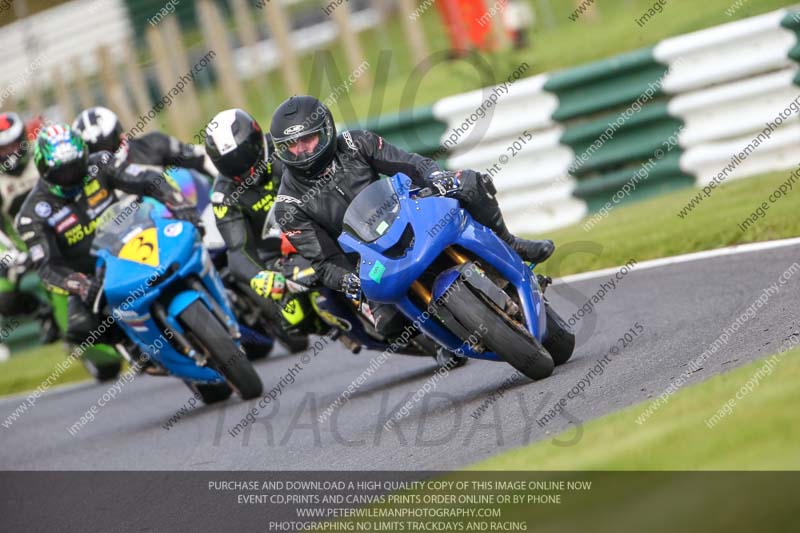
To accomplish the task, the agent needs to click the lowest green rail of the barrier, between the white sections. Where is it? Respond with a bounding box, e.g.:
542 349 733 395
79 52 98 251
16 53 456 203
573 152 695 211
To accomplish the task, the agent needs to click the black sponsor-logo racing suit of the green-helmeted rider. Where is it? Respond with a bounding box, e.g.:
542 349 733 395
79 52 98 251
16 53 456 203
16 152 191 342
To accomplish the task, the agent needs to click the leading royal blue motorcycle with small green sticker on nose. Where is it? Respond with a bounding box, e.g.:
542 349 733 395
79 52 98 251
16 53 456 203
339 174 575 379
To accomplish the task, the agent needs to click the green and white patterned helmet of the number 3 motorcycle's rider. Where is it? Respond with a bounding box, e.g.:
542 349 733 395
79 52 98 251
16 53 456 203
33 124 89 194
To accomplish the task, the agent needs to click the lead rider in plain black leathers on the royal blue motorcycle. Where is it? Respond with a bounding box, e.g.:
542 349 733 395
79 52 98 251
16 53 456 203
270 96 554 338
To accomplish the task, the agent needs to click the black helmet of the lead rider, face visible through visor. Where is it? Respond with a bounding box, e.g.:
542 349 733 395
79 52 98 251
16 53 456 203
269 96 336 178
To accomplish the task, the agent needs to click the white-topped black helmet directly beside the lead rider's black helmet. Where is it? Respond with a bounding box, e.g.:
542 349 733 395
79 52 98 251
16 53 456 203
206 109 272 183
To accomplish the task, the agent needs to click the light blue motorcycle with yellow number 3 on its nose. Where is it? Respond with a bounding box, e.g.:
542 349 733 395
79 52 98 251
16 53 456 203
92 199 263 403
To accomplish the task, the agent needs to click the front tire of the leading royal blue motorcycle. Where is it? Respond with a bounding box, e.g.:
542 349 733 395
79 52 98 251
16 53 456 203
445 286 555 380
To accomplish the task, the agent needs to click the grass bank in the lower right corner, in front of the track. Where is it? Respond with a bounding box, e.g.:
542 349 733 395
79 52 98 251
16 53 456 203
334 349 800 533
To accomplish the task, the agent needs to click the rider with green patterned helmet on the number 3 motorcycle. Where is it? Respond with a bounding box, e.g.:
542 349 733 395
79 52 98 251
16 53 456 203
16 124 197 344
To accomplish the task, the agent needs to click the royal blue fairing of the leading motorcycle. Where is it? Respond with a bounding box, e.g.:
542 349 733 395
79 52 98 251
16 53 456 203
339 174 546 360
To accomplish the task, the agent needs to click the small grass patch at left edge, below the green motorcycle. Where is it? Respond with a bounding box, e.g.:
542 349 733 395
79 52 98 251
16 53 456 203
0 342 91 395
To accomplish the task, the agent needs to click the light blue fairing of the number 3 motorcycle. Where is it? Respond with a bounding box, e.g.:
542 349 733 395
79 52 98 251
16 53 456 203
95 207 235 383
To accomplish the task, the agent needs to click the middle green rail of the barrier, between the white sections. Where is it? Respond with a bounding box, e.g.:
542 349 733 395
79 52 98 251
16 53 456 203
560 103 683 178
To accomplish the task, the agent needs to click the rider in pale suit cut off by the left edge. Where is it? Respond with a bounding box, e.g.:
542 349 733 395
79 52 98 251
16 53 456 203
0 112 58 349
